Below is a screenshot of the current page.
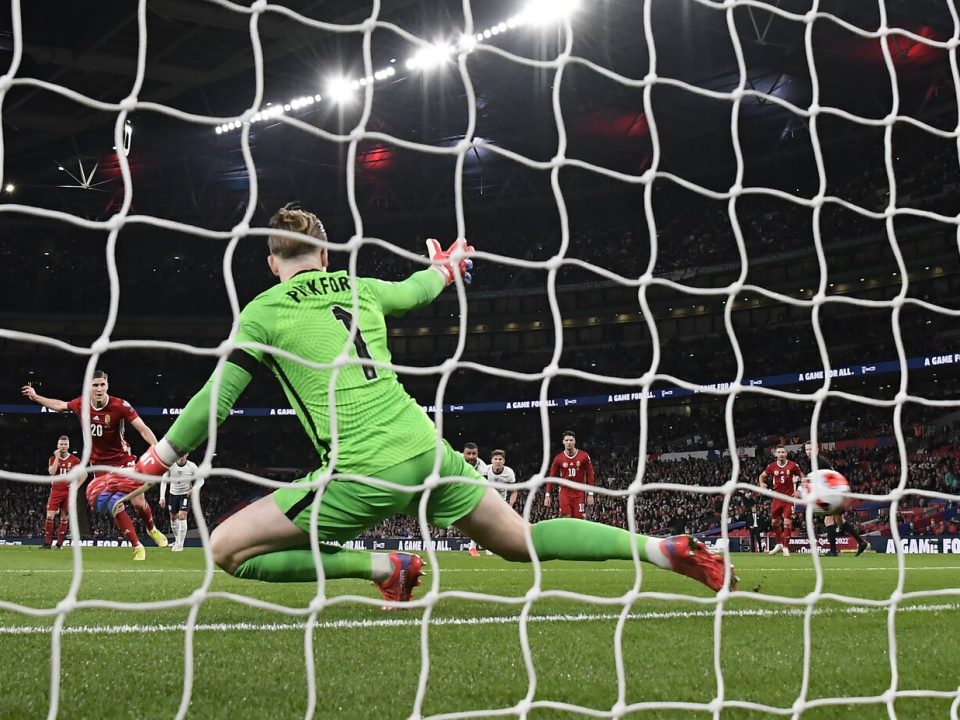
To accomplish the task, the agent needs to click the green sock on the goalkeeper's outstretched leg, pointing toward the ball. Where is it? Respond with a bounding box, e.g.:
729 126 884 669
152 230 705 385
530 518 670 568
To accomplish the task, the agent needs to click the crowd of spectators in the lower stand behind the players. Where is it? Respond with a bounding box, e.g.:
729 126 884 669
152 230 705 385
0 404 960 538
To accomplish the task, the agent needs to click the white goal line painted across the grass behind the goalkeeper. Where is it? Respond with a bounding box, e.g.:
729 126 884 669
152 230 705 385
0 603 960 635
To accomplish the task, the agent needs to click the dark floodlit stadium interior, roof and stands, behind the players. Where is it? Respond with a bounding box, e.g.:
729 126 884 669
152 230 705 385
0 0 960 538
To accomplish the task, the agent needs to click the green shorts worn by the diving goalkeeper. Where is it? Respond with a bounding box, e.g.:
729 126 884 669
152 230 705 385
273 440 487 542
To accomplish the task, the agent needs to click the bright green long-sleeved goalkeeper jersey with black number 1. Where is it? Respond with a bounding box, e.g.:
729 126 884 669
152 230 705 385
167 269 444 475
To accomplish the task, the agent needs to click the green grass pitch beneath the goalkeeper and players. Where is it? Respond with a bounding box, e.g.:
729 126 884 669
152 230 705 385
0 547 960 720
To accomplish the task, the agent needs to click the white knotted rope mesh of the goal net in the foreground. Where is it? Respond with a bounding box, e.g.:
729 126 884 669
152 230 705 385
0 0 960 720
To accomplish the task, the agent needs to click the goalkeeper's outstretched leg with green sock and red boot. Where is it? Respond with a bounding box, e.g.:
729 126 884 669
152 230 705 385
455 488 737 591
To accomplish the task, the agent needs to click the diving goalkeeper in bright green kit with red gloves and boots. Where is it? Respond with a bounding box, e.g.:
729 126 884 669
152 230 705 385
124 206 736 607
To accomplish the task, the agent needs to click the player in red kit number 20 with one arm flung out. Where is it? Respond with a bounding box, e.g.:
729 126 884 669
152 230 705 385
21 370 168 560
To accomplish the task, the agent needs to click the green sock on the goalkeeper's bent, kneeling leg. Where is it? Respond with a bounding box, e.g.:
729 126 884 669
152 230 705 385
235 545 373 582
